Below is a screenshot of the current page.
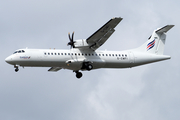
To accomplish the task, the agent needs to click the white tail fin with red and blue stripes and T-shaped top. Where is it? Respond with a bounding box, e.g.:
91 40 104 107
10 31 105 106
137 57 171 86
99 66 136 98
136 25 174 55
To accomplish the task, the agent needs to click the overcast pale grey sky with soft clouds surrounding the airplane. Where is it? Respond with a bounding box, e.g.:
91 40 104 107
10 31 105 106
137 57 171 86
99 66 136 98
0 0 180 120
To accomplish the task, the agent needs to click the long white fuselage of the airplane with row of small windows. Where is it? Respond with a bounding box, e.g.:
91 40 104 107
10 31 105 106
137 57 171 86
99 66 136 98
6 48 170 71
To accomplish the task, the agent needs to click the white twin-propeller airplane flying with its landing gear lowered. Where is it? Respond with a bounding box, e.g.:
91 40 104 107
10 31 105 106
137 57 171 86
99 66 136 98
5 17 174 78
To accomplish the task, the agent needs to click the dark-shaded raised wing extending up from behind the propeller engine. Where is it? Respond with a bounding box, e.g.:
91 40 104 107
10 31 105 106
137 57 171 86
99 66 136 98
87 17 122 50
